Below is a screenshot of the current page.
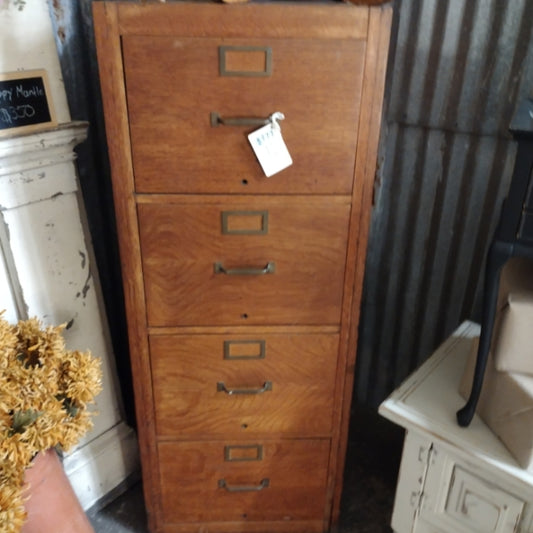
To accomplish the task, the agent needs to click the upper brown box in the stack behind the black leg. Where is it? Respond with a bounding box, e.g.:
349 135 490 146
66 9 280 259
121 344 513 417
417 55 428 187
491 258 533 375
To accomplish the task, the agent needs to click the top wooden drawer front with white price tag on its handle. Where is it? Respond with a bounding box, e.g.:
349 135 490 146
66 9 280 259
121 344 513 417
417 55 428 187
123 36 365 194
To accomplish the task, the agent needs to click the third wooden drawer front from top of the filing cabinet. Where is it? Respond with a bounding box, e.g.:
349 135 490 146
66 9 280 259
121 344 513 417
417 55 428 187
150 334 338 438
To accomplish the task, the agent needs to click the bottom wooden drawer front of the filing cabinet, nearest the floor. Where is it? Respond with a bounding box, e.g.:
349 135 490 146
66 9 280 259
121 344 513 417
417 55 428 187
158 440 329 523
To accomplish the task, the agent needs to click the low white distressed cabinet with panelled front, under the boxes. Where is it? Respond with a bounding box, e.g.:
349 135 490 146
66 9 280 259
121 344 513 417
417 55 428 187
379 322 533 533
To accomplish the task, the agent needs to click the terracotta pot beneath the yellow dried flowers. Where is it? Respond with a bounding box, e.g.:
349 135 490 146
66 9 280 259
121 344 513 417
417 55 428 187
21 450 94 533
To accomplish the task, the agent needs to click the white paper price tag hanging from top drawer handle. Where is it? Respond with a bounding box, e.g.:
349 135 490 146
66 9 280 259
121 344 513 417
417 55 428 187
248 113 292 178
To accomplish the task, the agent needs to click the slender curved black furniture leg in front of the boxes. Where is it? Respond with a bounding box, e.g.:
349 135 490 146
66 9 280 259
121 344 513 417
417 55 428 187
457 243 510 427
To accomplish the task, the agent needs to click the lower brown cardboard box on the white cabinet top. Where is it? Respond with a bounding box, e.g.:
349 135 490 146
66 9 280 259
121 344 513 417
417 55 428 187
459 339 533 472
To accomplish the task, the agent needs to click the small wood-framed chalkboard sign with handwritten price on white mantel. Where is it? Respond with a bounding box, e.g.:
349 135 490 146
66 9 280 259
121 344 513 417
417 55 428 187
0 70 57 137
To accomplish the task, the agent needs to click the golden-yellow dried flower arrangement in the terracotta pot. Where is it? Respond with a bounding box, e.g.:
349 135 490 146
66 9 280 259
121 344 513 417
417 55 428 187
0 313 101 533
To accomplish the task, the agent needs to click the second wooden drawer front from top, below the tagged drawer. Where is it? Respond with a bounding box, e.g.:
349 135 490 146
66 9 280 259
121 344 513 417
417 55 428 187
138 198 350 326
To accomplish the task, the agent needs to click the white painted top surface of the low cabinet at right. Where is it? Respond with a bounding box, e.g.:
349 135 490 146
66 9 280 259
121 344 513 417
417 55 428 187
379 322 533 483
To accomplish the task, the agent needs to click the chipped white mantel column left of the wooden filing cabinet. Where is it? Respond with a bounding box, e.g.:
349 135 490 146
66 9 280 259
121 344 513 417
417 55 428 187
0 0 138 509
